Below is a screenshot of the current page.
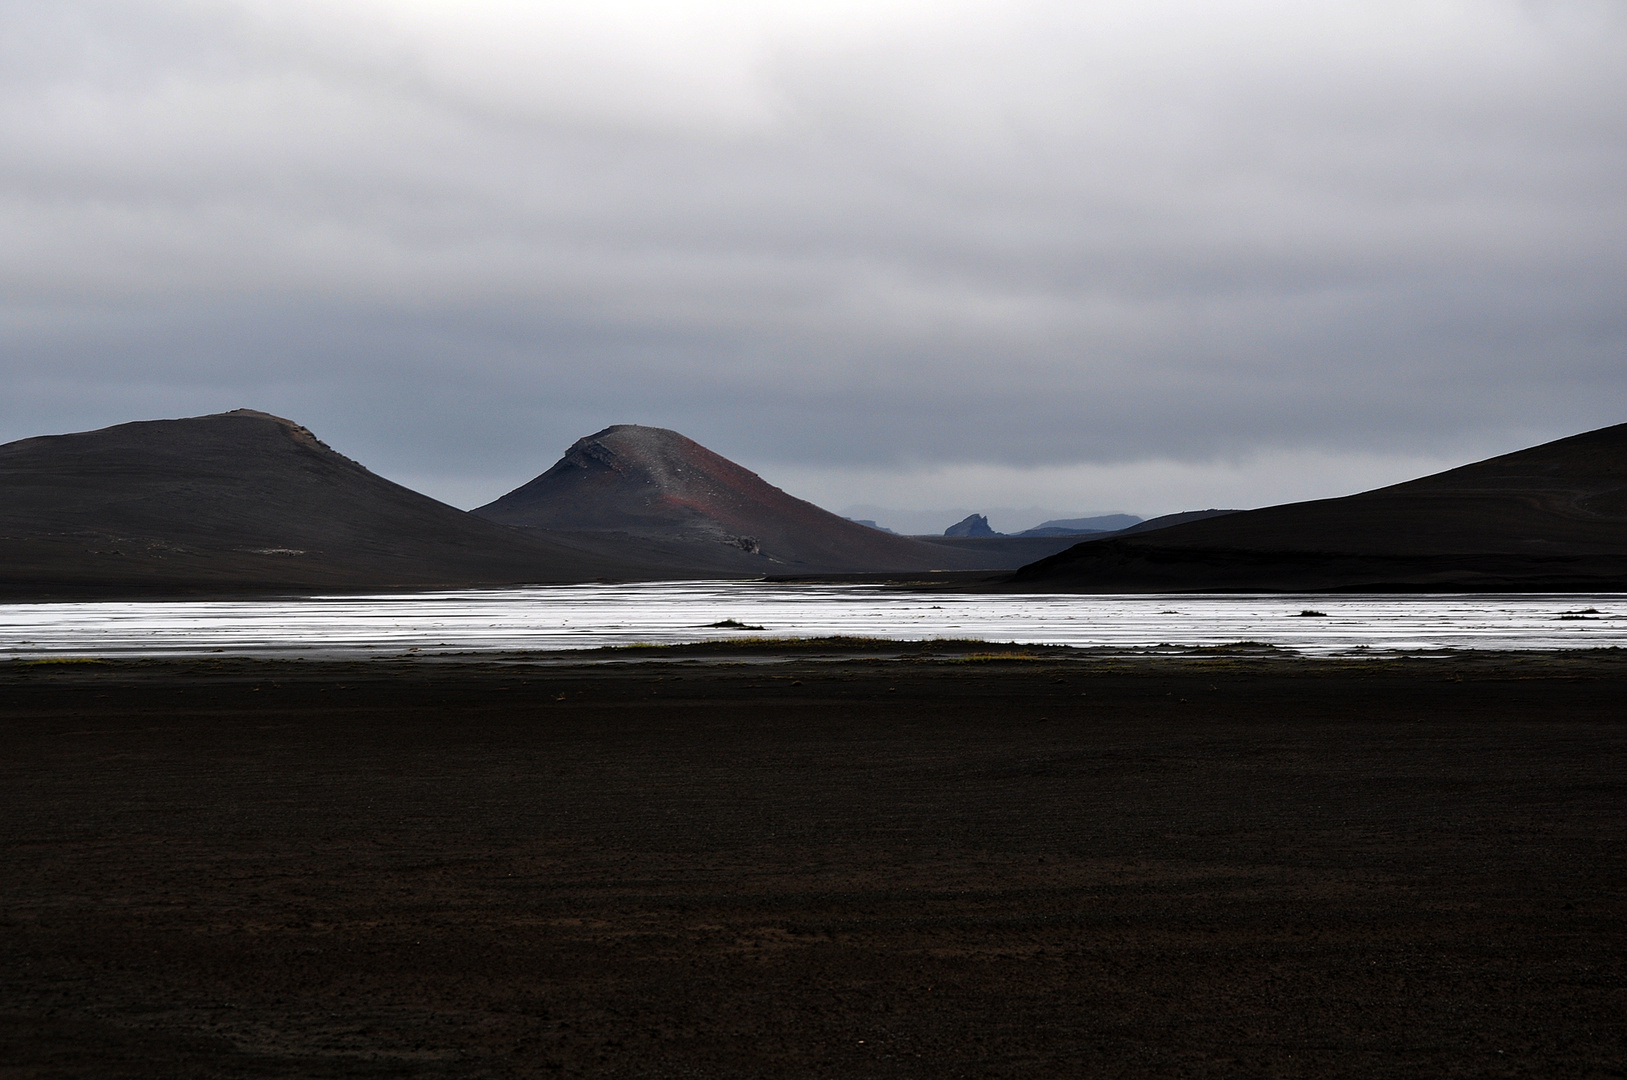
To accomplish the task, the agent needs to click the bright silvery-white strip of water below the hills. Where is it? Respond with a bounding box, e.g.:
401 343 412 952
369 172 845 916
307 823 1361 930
0 582 1627 660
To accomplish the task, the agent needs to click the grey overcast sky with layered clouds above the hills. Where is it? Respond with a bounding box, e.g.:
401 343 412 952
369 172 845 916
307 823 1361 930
0 0 1627 529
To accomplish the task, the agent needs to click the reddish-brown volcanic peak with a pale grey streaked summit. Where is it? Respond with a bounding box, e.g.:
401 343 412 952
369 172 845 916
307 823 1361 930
473 425 997 576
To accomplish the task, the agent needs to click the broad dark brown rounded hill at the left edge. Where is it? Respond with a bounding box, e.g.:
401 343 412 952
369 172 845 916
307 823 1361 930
0 410 662 597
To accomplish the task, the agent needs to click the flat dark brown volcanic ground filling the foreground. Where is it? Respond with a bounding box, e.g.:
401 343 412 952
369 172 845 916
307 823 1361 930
0 651 1627 1078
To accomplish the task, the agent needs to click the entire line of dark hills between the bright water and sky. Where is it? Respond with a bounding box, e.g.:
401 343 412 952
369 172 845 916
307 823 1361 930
0 410 1627 599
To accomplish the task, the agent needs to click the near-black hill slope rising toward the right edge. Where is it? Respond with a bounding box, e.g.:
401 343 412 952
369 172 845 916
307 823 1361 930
1012 425 1627 592
